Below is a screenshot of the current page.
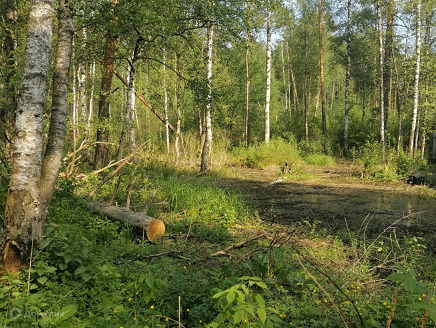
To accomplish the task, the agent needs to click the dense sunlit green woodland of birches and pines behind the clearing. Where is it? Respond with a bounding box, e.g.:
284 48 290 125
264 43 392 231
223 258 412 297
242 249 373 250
0 1 435 168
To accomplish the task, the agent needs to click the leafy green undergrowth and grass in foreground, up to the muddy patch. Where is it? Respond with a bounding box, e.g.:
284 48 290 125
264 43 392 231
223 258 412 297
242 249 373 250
0 164 435 328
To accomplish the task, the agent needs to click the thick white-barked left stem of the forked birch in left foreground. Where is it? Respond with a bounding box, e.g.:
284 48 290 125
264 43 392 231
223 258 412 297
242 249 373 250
1 0 54 271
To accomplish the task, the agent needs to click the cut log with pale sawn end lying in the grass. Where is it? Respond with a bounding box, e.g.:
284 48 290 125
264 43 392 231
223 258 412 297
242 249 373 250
91 203 165 241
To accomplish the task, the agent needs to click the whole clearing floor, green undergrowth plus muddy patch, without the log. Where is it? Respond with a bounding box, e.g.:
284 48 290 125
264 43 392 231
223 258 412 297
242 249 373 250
0 150 436 327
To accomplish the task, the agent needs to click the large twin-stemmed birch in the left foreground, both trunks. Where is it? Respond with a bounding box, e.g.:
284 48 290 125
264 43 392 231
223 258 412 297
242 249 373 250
2 0 72 271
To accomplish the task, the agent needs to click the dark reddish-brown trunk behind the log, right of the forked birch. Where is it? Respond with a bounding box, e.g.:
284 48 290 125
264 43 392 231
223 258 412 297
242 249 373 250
94 0 117 170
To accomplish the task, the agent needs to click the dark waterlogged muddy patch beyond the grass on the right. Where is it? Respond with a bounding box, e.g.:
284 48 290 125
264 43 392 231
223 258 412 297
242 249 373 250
216 164 436 238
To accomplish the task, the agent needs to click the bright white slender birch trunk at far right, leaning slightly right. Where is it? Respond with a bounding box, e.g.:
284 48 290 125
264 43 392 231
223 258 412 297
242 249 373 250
409 0 421 156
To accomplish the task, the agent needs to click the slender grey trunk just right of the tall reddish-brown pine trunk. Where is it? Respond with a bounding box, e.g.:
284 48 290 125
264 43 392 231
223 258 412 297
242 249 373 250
344 0 352 155
